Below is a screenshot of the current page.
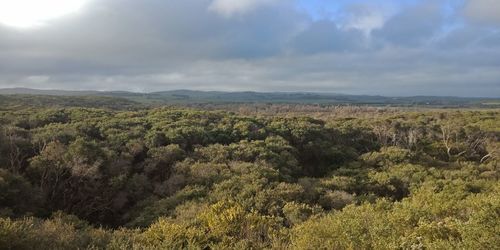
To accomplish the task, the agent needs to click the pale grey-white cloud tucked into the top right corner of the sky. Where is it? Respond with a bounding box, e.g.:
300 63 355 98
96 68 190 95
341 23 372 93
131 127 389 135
465 0 500 23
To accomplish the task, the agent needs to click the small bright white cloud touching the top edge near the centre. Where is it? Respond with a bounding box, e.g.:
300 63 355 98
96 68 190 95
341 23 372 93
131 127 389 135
209 0 281 17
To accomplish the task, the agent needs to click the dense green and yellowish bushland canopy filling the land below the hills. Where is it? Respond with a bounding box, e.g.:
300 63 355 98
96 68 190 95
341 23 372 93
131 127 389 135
0 94 500 249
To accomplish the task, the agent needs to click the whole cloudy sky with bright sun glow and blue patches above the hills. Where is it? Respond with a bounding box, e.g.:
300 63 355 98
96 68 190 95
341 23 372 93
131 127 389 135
0 0 500 97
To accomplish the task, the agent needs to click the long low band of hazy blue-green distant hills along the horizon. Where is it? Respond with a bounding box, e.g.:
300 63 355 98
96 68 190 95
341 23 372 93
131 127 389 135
0 88 500 107
